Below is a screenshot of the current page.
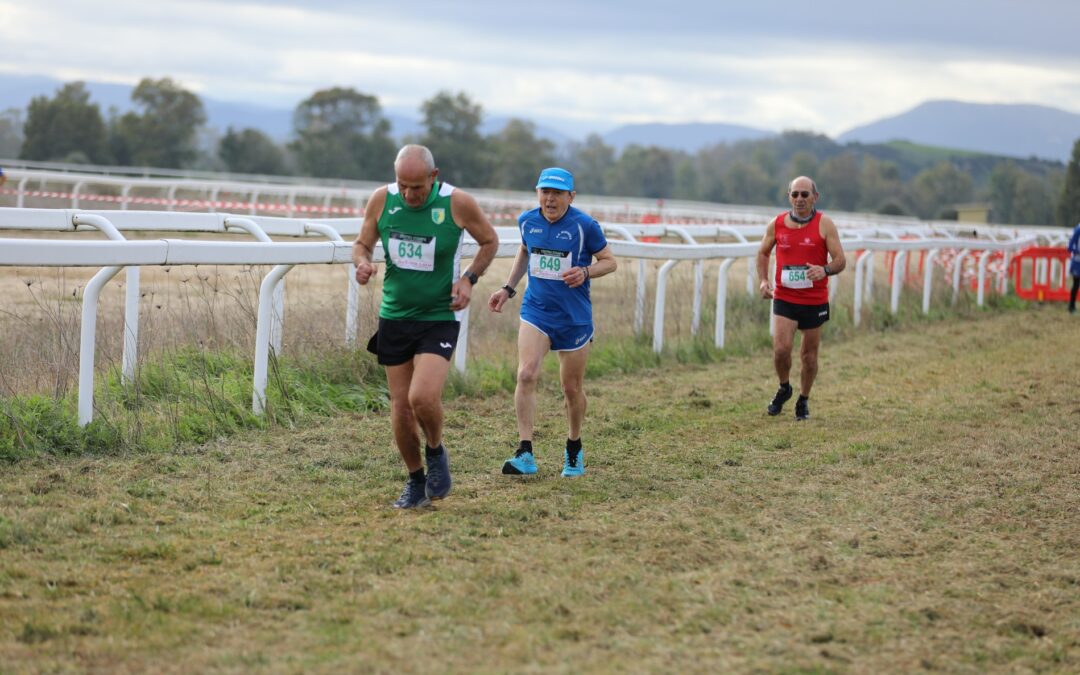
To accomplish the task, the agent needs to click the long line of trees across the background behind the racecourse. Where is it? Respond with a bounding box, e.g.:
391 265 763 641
0 78 1080 226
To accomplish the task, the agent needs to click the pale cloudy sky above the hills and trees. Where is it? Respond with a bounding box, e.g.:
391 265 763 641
0 0 1080 136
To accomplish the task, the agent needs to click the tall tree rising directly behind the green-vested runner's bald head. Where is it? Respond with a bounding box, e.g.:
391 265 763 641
420 91 491 187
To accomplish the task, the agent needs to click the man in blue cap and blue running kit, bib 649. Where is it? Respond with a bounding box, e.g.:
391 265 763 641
488 167 616 477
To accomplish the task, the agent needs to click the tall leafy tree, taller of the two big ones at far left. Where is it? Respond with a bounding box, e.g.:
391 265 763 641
112 78 206 168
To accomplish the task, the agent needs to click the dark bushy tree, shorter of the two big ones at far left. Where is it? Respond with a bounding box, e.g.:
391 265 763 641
19 82 112 164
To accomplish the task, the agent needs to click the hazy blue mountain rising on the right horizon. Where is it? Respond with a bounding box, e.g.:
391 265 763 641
838 100 1080 162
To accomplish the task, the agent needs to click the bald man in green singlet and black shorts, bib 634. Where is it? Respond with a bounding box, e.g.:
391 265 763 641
352 145 499 509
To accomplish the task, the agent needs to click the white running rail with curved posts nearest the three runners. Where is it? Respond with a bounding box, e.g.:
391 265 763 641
0 208 1057 424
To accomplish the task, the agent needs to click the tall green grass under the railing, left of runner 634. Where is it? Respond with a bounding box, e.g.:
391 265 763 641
0 349 387 462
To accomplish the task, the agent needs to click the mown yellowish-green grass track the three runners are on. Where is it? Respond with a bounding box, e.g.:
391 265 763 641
0 306 1080 673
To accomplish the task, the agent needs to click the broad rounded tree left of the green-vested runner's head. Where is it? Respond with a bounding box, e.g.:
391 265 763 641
289 86 396 179
